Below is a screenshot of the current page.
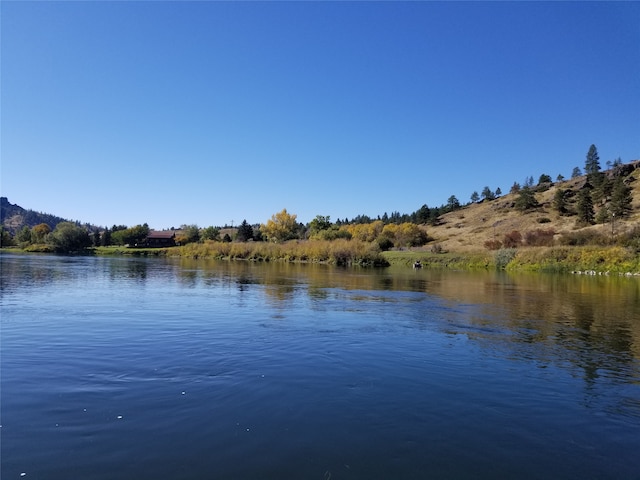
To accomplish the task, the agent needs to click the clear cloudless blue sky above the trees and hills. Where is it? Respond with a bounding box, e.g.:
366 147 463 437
0 1 640 229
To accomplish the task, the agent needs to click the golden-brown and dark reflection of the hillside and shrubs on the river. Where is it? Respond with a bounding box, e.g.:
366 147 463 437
165 261 640 403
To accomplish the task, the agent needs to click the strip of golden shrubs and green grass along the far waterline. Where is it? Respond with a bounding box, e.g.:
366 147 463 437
82 240 640 275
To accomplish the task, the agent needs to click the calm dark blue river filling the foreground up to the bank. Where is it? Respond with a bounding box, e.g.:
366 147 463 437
0 254 640 480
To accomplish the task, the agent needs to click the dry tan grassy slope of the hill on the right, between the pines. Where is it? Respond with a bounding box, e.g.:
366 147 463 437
425 161 640 252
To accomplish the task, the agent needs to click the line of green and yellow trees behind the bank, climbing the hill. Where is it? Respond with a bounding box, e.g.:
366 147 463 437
1 145 632 252
